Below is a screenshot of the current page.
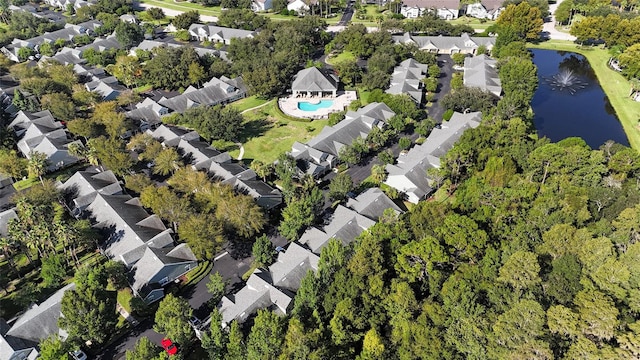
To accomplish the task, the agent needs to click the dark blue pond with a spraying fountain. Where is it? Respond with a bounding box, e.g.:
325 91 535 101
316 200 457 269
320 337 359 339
531 49 629 149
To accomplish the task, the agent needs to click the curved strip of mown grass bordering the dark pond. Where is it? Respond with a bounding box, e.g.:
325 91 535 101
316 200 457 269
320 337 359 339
529 40 640 150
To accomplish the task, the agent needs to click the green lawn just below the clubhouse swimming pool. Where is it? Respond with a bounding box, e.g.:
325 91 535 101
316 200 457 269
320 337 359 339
230 99 328 163
